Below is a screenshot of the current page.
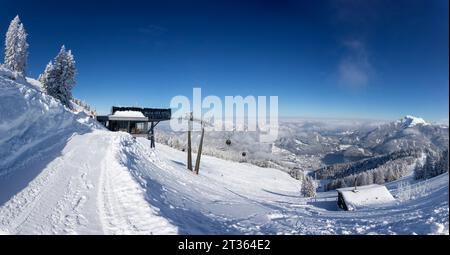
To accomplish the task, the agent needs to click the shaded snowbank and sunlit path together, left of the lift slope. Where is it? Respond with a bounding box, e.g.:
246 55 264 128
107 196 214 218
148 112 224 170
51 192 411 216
0 66 177 234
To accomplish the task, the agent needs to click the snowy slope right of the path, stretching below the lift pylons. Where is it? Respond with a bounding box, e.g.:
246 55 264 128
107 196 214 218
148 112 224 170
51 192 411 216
117 139 448 234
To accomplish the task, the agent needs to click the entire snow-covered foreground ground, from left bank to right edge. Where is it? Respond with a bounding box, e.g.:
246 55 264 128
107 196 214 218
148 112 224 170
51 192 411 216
0 68 449 234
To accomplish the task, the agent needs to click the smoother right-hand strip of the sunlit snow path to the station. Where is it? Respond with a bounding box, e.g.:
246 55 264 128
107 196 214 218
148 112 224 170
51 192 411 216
99 133 177 234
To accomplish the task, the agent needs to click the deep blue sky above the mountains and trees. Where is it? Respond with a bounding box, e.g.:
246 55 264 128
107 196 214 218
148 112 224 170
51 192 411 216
0 0 449 121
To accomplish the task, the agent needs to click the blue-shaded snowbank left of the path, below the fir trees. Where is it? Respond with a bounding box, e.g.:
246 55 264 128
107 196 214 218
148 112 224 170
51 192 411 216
0 67 100 176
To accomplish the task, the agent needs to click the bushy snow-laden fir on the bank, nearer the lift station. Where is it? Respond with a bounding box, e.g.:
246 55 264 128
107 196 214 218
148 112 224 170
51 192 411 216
39 45 76 108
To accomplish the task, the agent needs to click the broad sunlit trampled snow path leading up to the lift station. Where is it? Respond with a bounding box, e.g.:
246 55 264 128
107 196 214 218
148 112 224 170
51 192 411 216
0 131 176 234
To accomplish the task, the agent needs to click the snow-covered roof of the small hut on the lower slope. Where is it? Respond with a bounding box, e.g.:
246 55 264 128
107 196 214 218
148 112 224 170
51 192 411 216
336 184 395 210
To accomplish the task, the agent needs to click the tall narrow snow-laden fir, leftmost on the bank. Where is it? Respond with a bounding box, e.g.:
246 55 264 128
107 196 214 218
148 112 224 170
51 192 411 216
4 16 28 75
